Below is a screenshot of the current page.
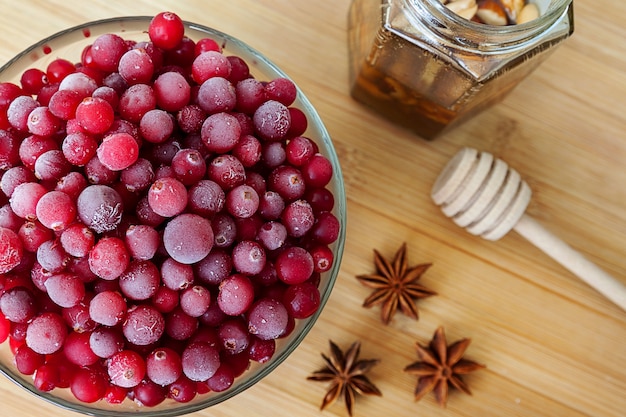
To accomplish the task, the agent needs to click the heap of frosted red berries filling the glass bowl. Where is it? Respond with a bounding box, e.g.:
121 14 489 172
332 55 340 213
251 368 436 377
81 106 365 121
0 12 340 406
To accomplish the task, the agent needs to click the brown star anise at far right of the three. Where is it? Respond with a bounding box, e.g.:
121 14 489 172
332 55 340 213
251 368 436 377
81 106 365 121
404 327 485 407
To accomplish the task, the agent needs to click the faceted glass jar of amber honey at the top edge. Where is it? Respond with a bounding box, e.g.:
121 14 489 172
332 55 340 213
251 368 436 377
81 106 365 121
349 0 574 140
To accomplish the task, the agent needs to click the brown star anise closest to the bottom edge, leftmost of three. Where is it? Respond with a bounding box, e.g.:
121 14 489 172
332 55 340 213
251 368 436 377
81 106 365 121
307 341 382 416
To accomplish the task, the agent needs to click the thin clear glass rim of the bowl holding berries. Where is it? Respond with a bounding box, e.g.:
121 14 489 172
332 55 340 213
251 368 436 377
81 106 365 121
0 15 347 417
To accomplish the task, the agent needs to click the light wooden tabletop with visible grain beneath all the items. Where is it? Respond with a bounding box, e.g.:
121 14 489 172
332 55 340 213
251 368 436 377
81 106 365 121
0 0 626 417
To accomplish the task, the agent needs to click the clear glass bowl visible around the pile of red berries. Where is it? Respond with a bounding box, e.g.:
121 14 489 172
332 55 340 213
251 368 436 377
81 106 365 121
0 16 346 417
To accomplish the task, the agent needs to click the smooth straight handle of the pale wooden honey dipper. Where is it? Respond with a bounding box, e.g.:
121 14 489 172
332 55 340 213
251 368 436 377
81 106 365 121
514 215 626 310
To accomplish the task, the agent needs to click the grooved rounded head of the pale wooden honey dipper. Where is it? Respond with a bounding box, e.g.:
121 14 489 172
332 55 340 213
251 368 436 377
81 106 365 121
431 148 531 240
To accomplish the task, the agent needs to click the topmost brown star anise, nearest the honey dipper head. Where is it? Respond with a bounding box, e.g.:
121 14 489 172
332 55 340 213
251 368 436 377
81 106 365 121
357 243 437 324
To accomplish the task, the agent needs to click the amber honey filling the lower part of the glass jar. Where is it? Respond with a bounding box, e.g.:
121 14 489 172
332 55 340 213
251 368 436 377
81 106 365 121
349 0 571 140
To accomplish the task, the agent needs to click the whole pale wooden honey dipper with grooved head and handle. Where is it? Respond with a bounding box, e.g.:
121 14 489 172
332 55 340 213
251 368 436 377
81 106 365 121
431 148 626 310
